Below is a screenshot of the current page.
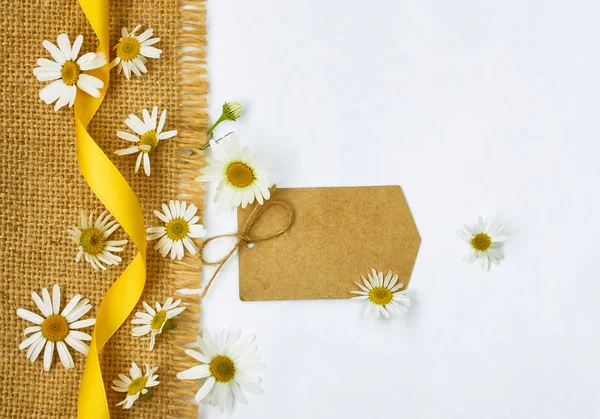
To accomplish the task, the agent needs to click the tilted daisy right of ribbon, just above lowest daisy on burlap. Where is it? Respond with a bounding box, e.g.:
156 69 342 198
131 297 185 351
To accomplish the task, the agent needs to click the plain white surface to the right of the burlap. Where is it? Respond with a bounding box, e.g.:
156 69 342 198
200 0 600 419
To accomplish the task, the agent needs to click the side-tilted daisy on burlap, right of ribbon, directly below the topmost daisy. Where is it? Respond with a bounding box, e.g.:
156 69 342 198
115 106 177 176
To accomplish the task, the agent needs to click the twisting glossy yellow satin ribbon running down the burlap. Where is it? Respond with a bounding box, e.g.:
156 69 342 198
75 0 146 419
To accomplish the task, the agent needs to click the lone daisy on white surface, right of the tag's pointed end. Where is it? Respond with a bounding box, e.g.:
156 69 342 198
456 215 506 271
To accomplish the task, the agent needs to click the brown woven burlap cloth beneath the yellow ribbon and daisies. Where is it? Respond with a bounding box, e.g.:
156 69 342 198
0 0 207 418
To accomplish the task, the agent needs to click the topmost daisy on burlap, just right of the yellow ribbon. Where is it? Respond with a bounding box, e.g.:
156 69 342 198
110 25 162 79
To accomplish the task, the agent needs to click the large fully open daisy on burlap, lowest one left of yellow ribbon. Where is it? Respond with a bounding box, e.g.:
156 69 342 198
17 285 96 371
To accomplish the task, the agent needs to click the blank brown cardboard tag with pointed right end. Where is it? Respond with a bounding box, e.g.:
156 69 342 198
238 186 421 301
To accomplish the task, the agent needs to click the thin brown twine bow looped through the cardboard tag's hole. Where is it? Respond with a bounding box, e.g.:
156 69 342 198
199 190 294 299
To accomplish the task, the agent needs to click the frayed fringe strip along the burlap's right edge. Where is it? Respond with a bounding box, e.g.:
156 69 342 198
166 0 208 418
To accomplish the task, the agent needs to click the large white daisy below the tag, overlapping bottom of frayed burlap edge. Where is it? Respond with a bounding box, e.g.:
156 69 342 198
177 330 265 411
